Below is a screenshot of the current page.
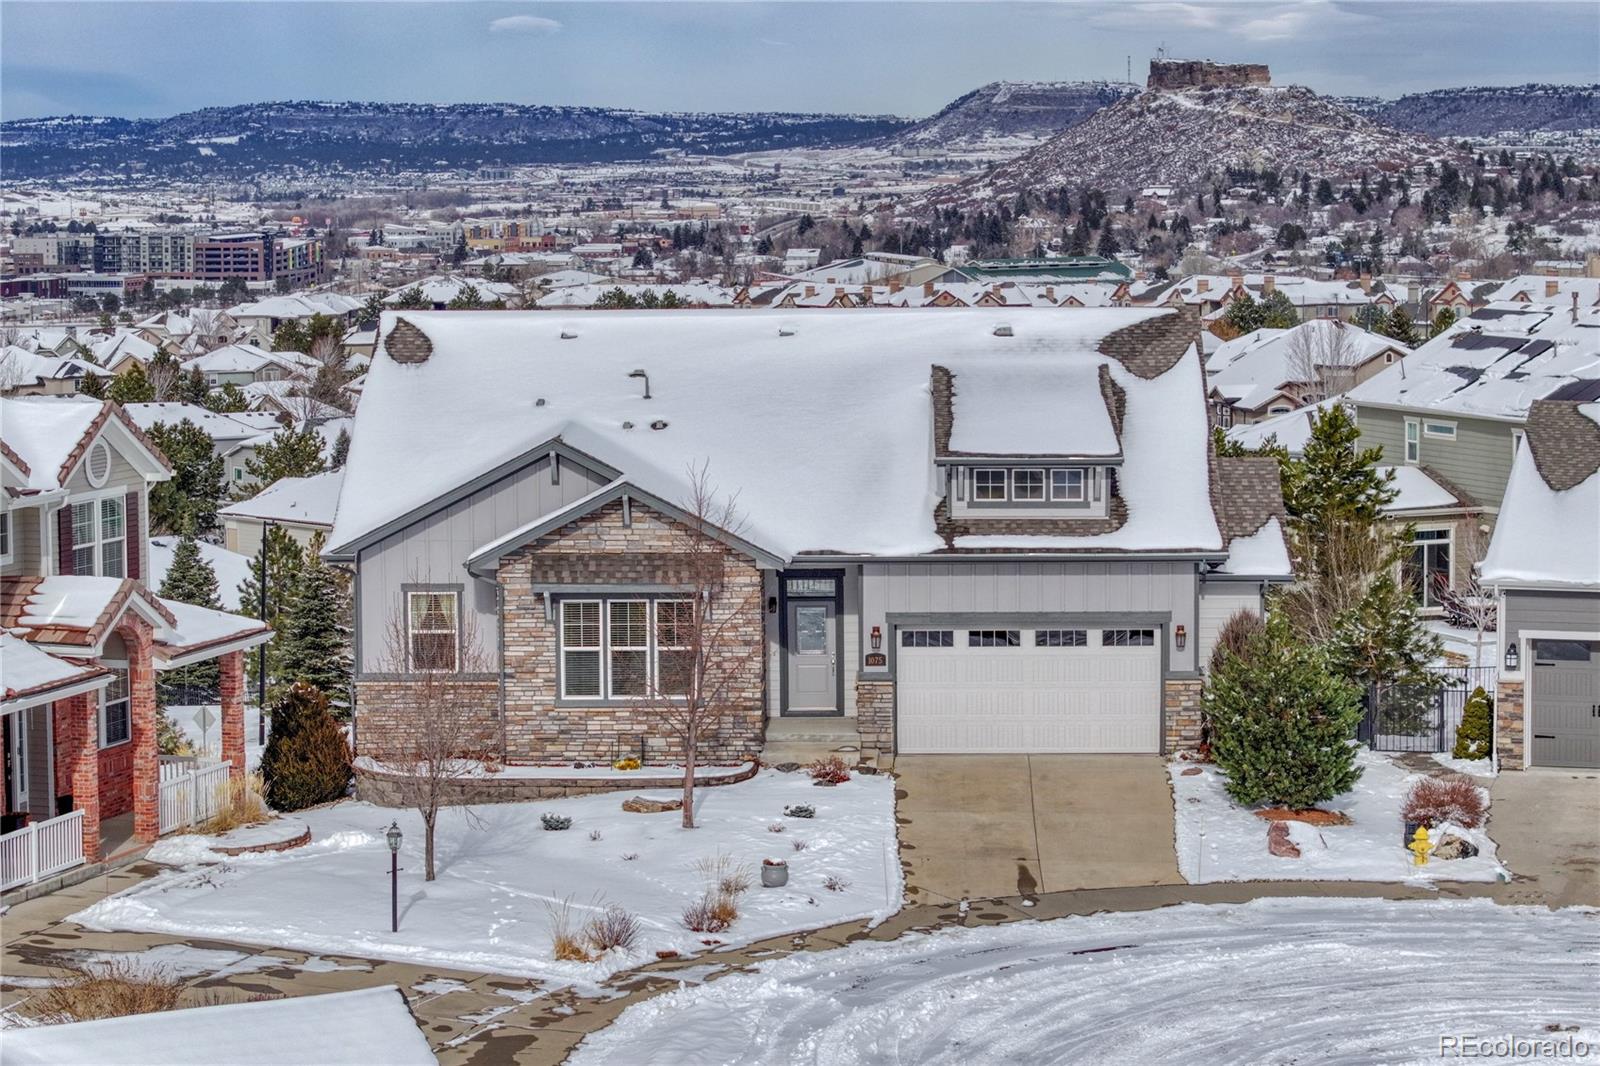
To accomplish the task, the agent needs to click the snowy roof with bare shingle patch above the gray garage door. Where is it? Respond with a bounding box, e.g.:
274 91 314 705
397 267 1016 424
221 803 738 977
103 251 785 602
1478 402 1600 589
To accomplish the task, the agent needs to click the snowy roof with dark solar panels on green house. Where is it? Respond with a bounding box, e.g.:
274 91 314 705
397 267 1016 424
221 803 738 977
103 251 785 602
1347 303 1600 421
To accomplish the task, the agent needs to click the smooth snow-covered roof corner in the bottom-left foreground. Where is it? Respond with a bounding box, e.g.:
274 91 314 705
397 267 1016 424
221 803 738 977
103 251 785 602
5 984 438 1066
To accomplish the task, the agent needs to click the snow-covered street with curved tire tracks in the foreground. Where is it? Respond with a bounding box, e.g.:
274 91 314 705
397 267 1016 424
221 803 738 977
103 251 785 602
568 898 1600 1066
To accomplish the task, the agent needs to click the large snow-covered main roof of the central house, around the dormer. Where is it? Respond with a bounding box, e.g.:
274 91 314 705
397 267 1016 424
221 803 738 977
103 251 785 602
330 307 1222 557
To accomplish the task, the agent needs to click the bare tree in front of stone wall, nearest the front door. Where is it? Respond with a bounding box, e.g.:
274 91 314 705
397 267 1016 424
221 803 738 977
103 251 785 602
646 464 765 829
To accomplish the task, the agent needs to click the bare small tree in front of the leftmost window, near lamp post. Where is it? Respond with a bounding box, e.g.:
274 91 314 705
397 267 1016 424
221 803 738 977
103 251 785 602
371 575 496 880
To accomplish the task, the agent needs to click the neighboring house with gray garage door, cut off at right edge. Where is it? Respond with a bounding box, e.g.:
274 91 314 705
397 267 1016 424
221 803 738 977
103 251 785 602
1480 393 1600 770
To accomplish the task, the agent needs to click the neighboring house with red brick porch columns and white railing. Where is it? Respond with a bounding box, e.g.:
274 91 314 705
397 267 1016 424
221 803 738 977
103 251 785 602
0 397 270 888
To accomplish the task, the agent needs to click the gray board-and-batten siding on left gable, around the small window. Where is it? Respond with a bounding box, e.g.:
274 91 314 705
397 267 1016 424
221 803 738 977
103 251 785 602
357 458 606 674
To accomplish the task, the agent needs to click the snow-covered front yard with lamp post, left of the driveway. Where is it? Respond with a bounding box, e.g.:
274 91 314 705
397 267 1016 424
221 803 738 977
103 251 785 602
74 771 902 986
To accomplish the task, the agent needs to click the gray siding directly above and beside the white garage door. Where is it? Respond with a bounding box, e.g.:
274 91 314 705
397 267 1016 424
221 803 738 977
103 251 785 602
861 560 1197 677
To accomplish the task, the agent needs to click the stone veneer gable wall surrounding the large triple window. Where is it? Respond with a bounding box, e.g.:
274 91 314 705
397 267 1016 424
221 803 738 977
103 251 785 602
499 501 766 763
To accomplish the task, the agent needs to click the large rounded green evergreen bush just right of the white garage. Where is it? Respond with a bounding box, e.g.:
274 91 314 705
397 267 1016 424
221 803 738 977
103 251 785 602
1203 616 1362 808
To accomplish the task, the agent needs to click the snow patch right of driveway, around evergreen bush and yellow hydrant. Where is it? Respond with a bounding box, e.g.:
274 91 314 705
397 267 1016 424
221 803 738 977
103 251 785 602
1168 747 1510 885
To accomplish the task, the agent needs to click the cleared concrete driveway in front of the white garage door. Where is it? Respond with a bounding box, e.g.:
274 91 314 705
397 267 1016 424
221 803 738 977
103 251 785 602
888 755 1184 904
